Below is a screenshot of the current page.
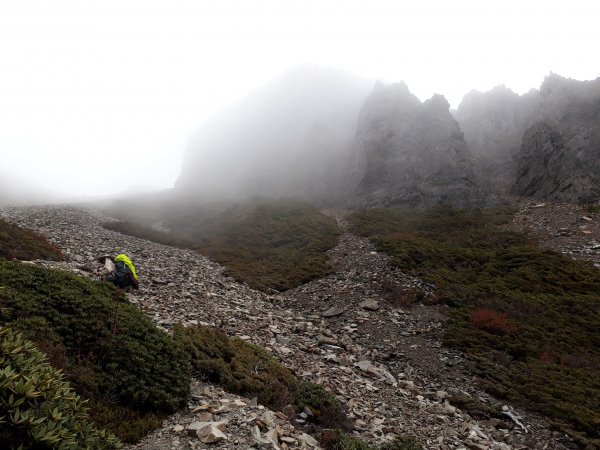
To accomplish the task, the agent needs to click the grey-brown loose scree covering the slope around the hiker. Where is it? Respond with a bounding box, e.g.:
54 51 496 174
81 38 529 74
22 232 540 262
0 206 573 450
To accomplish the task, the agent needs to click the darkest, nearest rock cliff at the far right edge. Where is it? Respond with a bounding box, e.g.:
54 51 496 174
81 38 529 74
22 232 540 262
513 75 600 202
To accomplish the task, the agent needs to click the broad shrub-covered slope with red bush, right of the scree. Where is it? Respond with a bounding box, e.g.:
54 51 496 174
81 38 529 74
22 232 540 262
352 207 600 445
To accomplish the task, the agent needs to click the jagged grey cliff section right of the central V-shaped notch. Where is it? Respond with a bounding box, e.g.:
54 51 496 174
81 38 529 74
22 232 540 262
455 74 600 202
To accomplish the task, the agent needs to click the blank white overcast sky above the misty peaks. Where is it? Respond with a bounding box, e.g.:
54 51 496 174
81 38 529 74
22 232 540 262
0 0 600 195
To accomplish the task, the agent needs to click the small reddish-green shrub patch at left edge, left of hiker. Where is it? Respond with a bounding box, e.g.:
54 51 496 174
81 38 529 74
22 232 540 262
0 219 63 261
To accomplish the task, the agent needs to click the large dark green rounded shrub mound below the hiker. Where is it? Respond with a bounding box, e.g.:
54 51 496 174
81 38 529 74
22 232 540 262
0 260 190 439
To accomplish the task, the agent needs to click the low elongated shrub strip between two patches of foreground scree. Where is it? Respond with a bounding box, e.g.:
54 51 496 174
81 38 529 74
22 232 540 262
173 325 347 427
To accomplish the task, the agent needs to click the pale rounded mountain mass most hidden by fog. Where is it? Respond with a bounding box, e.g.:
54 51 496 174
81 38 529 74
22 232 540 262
176 66 372 200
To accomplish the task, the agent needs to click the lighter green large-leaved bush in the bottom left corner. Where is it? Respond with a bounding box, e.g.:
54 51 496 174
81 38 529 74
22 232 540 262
0 328 122 449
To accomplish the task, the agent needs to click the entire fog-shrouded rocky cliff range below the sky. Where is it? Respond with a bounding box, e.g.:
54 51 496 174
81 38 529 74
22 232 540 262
176 66 600 207
